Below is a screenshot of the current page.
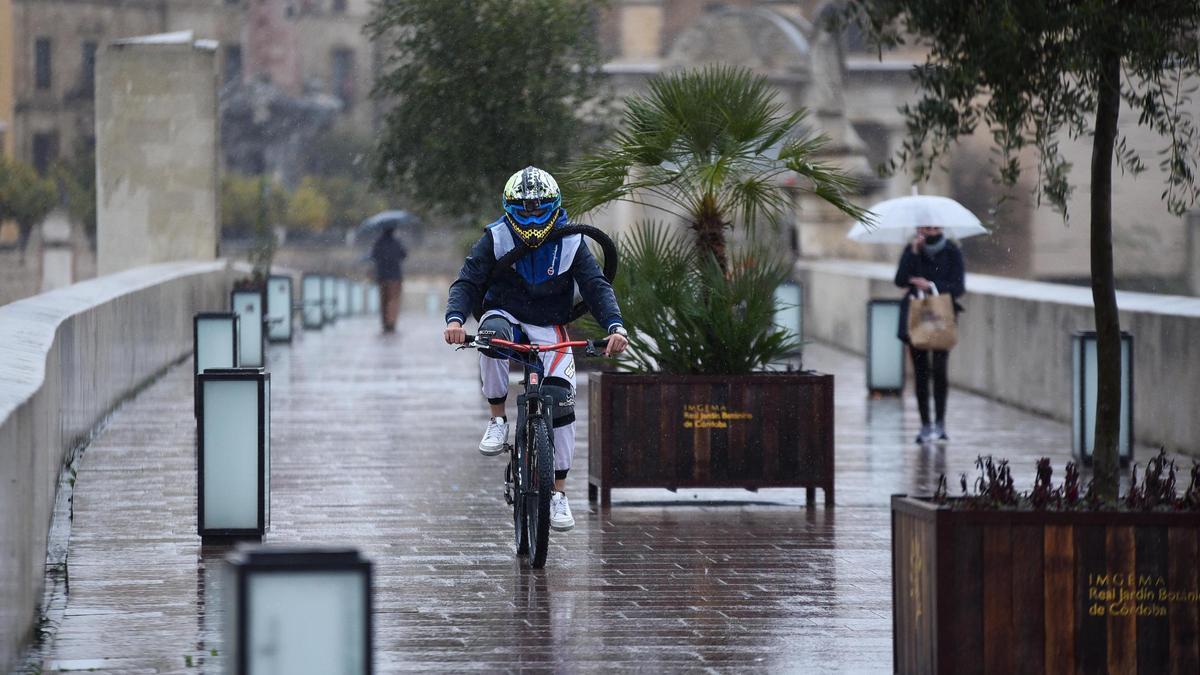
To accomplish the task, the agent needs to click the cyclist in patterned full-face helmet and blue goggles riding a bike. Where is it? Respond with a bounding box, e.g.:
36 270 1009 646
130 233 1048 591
443 167 628 531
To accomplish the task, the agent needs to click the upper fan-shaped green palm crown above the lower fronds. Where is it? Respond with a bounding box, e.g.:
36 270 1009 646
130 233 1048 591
563 66 865 273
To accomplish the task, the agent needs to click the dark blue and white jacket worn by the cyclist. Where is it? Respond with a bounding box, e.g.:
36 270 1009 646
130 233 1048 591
445 217 624 330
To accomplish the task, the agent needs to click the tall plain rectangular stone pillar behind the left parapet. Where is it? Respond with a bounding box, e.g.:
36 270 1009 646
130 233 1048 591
96 31 220 275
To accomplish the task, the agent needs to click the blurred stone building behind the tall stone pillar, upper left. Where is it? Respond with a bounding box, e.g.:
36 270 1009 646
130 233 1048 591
8 0 374 176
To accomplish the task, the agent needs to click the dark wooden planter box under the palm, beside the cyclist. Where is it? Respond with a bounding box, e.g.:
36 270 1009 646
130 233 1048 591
588 372 834 506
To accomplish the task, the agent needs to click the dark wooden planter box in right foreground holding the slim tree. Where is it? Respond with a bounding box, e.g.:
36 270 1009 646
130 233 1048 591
892 495 1200 674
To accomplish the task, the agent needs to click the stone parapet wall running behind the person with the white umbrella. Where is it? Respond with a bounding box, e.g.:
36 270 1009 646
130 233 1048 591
796 261 1200 455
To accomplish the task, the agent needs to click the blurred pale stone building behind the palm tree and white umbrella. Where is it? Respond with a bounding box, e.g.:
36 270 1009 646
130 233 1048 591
600 0 1200 294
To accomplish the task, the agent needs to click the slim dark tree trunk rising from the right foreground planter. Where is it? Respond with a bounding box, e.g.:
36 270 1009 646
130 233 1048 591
1091 52 1121 502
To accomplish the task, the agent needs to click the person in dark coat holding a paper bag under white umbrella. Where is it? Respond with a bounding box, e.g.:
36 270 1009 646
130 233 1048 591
895 227 966 443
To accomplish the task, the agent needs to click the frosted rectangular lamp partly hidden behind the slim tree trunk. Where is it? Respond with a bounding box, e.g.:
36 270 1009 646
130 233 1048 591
1070 330 1133 466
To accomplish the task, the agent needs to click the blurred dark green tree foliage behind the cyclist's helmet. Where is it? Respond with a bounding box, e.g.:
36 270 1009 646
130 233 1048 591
366 0 608 220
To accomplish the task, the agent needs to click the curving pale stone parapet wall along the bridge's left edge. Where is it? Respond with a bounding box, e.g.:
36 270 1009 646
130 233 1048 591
0 261 242 673
